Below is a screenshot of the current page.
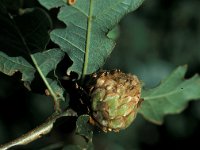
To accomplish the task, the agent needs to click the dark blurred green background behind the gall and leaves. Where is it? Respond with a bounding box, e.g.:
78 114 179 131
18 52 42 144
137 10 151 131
0 0 200 150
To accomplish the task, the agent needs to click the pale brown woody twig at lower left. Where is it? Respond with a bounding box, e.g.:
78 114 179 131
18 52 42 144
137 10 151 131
0 109 77 150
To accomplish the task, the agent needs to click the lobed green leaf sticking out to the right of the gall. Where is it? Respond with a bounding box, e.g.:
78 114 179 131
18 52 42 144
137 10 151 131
140 66 200 124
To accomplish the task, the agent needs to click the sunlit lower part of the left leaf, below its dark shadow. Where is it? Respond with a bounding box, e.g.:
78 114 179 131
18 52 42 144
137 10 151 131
0 49 64 100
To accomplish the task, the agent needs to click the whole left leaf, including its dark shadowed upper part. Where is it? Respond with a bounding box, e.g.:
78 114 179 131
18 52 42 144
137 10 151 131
0 5 64 100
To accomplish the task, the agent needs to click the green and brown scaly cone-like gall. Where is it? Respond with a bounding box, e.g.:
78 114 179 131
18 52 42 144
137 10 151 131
89 70 142 132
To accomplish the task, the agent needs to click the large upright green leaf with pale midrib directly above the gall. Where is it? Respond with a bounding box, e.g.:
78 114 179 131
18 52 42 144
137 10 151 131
39 0 143 77
